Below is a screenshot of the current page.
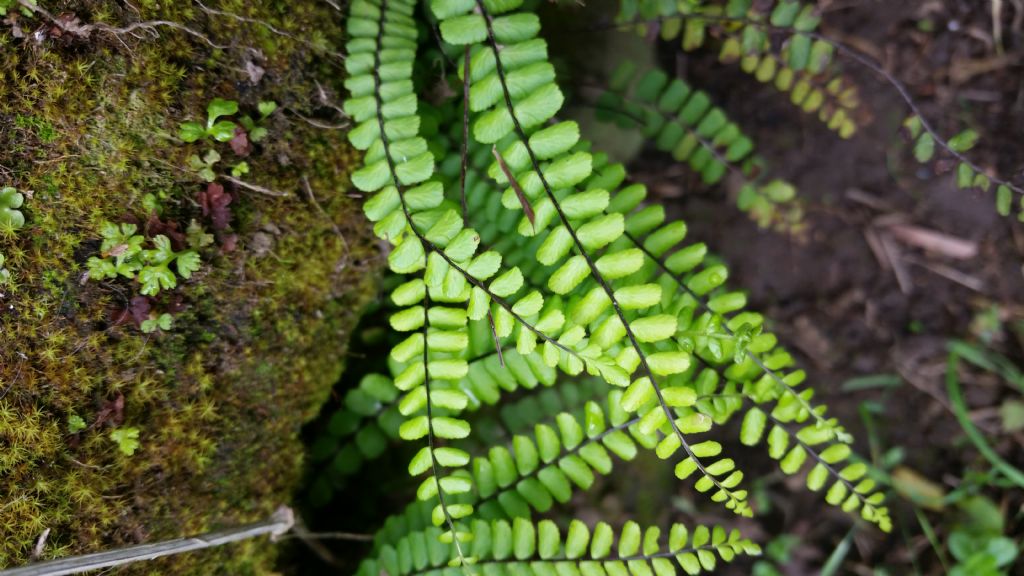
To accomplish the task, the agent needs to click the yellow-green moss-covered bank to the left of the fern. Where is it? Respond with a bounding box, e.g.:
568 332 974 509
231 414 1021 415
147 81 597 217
0 0 379 574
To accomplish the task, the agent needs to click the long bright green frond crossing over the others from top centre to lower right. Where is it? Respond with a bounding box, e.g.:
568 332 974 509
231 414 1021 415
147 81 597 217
432 0 752 515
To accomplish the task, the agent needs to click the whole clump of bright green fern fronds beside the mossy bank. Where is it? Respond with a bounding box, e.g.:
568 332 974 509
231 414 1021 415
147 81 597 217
343 0 891 574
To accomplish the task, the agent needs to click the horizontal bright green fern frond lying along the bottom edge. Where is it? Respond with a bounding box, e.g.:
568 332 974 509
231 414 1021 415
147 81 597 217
356 518 761 576
